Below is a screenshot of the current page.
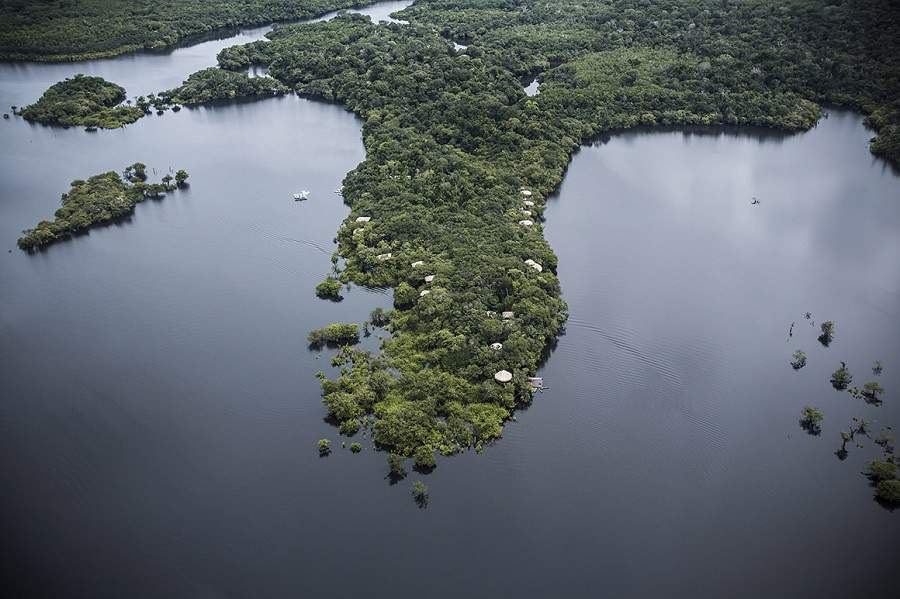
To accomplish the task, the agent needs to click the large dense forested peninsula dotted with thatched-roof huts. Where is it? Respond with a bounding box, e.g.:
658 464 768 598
178 0 900 464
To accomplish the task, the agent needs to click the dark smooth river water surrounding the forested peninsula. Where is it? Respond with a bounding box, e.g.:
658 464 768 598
0 3 900 598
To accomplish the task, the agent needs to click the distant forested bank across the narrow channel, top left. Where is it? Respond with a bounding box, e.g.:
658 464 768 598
0 0 384 61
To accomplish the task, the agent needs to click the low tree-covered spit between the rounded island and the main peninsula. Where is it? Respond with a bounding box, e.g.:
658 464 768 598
160 67 287 106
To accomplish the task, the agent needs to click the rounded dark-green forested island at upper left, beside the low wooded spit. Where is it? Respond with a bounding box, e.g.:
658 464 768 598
18 75 144 129
